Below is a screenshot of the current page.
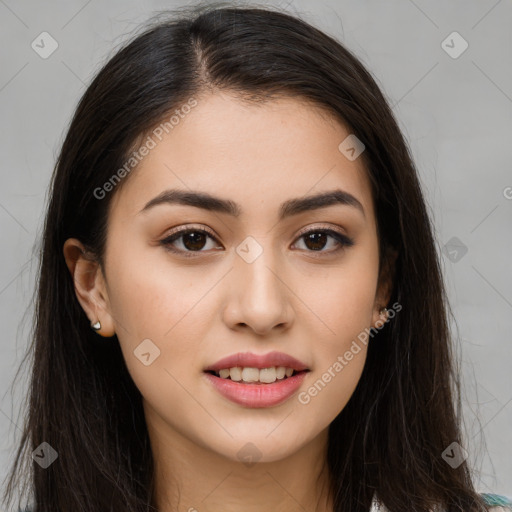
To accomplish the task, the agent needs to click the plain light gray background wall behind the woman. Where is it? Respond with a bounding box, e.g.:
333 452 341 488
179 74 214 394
0 0 512 504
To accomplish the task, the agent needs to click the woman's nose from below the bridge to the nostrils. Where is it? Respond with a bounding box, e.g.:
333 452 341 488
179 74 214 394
224 243 293 335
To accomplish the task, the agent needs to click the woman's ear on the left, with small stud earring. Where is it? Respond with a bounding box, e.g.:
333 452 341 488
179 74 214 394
63 238 115 337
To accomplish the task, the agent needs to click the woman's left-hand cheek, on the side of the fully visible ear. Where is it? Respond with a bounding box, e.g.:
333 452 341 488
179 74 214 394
103 242 218 386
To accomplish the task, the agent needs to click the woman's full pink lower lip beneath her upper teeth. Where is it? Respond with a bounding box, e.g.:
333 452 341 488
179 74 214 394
205 371 308 407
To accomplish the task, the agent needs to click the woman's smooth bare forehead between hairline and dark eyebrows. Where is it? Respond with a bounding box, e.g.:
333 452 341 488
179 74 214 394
111 92 373 222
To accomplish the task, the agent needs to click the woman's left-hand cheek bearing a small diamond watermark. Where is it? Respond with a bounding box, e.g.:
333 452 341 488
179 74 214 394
107 263 212 413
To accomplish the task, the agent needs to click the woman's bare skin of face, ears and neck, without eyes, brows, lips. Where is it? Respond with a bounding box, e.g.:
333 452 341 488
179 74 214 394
64 92 391 512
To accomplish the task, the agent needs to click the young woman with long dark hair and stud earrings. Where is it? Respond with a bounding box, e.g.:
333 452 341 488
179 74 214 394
5 7 506 512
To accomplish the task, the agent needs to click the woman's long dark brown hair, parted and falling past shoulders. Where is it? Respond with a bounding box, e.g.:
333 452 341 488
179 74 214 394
4 5 485 512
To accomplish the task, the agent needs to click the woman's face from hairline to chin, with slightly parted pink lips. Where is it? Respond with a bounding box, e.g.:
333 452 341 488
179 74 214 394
66 93 387 462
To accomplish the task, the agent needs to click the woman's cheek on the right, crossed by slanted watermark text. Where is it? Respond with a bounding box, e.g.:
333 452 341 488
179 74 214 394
298 251 378 420
